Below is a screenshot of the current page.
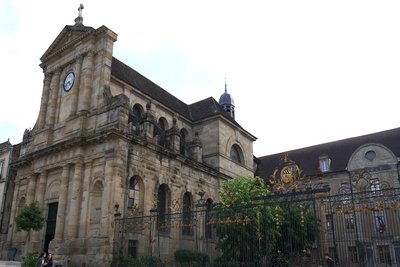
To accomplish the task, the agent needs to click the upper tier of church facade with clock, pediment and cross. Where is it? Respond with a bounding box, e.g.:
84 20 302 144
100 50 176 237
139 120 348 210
35 4 117 148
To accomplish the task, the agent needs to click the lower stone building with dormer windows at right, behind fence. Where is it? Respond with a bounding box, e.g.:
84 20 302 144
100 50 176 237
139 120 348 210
256 128 400 266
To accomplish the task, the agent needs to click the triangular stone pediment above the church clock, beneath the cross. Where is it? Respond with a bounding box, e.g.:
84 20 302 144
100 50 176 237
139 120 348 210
40 25 95 62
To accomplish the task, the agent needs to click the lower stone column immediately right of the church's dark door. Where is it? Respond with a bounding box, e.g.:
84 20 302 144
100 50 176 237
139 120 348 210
54 164 69 241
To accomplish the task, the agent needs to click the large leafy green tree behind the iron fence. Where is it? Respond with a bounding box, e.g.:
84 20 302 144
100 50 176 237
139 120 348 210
211 177 317 266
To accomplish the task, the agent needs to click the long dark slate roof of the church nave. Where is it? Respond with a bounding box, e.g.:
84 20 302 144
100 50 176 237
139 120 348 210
111 57 255 138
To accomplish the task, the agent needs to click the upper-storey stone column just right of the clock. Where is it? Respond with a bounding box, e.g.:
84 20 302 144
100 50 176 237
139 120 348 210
78 51 94 113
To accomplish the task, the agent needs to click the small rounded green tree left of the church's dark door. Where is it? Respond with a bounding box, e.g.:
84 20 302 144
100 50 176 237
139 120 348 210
15 201 44 231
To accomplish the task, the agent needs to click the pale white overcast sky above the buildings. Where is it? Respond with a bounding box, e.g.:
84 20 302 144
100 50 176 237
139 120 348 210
0 0 400 156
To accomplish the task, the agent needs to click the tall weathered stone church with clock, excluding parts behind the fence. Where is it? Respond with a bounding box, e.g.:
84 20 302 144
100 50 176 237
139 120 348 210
5 12 256 266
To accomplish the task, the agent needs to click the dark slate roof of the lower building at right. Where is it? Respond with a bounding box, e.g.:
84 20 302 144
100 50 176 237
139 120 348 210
256 128 400 179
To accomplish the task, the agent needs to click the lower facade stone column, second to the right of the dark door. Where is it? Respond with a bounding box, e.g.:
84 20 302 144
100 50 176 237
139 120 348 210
68 160 83 239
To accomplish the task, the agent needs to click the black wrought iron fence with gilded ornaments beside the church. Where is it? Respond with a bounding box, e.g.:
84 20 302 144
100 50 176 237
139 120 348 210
114 189 400 267
